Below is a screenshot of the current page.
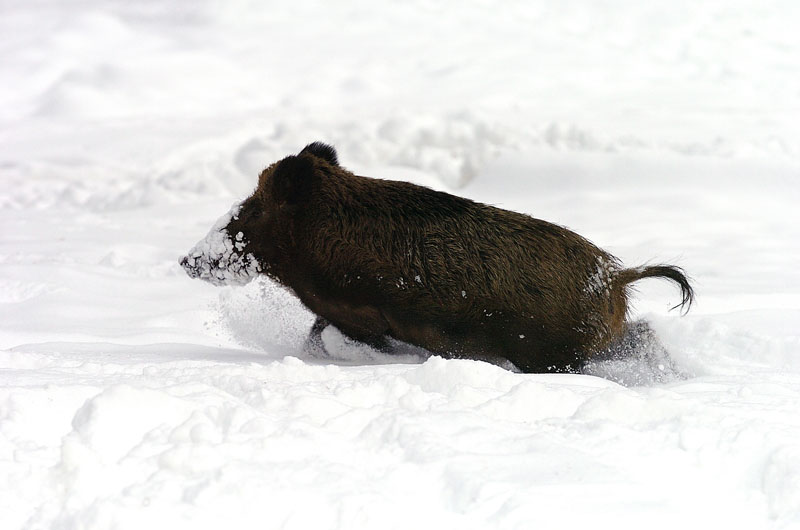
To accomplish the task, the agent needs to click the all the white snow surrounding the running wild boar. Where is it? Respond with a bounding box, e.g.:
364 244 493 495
0 0 800 529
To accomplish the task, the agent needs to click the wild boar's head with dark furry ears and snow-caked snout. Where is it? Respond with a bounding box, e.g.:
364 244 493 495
180 142 338 285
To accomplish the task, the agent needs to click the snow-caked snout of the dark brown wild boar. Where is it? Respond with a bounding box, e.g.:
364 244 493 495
180 203 261 285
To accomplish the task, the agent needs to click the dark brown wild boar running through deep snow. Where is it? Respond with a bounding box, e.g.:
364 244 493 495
181 142 694 372
